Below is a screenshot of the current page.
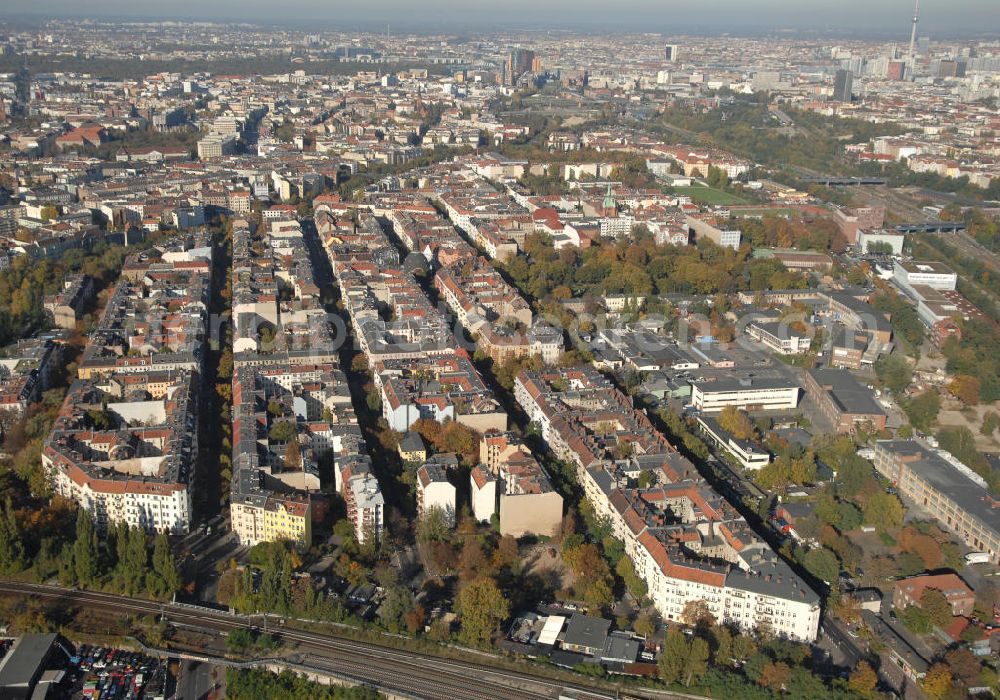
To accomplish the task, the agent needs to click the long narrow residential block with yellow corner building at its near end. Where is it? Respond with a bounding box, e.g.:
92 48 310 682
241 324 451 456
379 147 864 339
230 216 383 547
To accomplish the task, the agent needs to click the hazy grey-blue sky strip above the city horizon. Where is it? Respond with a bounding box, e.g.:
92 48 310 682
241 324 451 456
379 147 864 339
7 0 1000 37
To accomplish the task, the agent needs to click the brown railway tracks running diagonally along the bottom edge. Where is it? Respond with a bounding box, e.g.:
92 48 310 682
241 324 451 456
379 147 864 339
0 582 624 700
